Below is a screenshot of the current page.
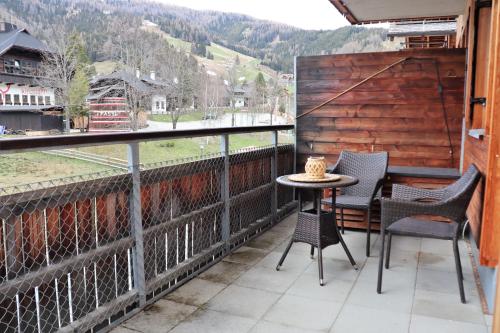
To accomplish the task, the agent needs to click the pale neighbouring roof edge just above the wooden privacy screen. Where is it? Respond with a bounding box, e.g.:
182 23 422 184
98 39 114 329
387 21 457 36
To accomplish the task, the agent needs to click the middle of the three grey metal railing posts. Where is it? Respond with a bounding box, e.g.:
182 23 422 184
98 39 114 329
220 134 231 252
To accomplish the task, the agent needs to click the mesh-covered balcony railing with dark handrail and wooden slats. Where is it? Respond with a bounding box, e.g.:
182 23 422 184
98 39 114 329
0 125 295 333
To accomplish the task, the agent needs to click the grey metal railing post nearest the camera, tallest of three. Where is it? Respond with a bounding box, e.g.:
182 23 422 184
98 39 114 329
128 142 146 307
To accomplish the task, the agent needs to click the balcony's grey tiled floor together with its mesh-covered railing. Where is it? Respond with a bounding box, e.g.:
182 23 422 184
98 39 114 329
0 125 491 333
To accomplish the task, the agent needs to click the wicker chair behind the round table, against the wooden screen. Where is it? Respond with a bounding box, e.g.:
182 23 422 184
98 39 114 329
323 151 389 257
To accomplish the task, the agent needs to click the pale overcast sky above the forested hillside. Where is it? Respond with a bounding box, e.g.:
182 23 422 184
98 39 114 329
156 0 348 29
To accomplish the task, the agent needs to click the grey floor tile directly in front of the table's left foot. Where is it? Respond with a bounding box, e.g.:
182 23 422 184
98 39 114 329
234 267 299 293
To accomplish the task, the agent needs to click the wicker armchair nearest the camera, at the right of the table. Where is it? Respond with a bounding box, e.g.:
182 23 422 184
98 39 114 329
377 164 481 303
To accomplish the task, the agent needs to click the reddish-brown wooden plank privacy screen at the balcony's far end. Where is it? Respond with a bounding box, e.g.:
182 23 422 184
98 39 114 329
296 49 465 170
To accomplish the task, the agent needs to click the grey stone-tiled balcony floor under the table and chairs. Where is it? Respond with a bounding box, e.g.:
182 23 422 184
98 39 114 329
113 215 491 333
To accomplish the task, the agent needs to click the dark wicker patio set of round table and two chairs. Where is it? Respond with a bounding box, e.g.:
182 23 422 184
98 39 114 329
276 151 481 303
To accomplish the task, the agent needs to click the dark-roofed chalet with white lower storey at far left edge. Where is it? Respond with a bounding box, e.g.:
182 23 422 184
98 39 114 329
0 22 63 131
